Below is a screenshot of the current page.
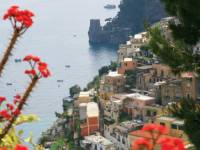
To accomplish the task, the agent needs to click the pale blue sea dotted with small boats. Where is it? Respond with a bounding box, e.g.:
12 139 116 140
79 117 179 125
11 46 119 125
0 0 119 142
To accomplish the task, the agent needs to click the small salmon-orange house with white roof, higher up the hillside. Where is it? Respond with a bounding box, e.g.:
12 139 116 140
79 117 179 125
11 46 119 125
118 58 137 74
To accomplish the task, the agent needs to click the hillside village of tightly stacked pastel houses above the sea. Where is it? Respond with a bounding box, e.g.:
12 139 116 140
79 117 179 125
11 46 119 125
40 17 200 150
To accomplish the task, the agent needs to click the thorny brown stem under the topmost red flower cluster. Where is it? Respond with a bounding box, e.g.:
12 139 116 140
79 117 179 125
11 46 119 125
0 29 20 76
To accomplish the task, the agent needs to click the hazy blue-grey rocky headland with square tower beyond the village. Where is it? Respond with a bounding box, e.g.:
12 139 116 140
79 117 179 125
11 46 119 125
88 0 166 44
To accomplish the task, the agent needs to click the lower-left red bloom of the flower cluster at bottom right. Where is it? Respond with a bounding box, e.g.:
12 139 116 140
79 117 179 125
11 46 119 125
132 138 152 150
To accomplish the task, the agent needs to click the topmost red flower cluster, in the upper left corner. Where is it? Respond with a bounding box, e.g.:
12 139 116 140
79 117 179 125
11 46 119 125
3 6 34 28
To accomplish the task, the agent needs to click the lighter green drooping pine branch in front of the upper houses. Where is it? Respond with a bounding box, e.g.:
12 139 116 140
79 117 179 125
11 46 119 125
149 28 200 73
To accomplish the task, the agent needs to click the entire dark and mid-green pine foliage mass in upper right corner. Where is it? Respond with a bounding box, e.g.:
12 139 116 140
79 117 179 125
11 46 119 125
149 0 200 73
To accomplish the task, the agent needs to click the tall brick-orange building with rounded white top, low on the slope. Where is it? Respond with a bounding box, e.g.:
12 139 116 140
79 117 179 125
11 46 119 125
79 102 99 136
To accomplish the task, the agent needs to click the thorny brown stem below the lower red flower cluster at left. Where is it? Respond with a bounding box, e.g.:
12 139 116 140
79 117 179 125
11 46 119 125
0 76 39 143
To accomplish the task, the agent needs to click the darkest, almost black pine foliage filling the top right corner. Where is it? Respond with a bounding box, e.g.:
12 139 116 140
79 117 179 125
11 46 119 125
162 0 200 45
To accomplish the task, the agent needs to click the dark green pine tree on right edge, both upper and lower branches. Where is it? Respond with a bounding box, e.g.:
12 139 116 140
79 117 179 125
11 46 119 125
149 0 200 149
